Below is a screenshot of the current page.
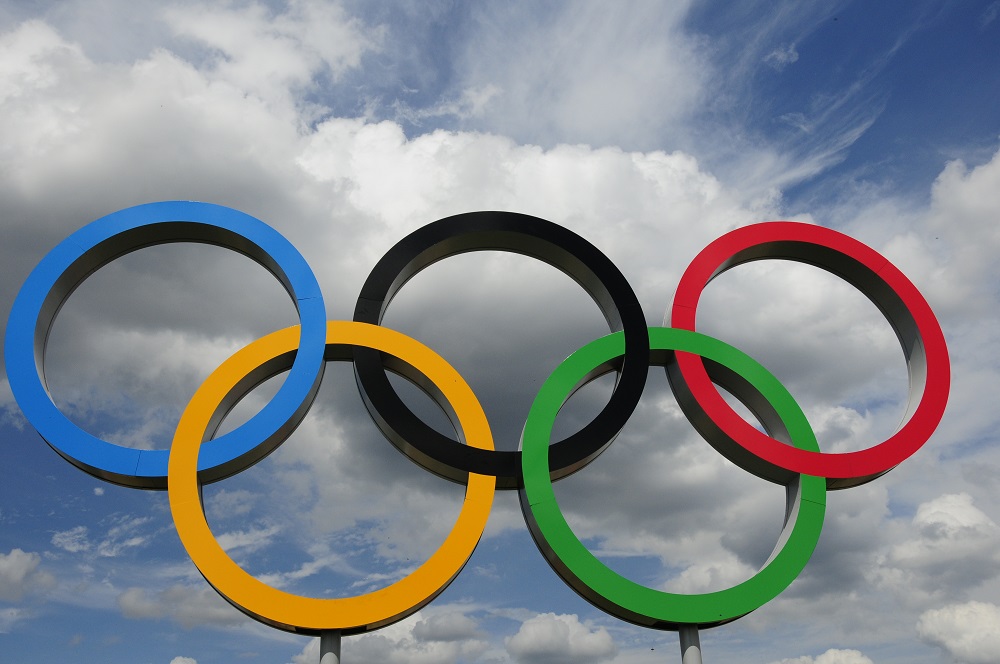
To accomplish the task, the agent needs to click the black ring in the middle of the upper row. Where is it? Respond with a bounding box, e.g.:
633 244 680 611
354 212 649 489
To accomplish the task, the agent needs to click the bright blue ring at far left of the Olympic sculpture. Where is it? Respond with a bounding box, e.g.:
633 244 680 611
4 201 326 489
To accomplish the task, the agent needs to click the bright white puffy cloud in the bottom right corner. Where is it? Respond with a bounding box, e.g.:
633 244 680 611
917 602 1000 664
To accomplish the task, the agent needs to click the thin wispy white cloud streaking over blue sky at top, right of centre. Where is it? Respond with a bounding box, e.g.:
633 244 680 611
414 2 891 201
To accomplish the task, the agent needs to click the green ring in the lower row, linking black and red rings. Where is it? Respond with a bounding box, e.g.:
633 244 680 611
520 327 826 630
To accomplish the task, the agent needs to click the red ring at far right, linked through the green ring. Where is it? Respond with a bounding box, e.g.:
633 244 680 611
668 221 951 489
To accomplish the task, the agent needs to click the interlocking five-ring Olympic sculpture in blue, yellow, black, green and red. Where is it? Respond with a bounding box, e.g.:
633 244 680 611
4 202 951 634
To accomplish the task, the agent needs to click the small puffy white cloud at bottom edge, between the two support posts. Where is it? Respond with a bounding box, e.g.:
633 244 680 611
506 613 618 664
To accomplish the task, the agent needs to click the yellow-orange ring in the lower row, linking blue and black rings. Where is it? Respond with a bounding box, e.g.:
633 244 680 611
167 321 496 634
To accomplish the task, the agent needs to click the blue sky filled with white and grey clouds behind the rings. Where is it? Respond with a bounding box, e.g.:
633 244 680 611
0 0 1000 664
